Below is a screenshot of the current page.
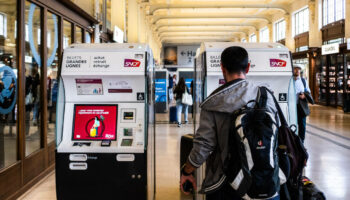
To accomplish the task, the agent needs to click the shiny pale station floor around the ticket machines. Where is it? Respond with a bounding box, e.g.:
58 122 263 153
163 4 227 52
19 106 350 200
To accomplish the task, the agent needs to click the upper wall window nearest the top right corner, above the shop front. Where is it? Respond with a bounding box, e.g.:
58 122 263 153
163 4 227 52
323 0 345 26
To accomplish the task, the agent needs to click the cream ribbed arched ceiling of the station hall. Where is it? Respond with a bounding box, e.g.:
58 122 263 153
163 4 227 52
141 0 294 44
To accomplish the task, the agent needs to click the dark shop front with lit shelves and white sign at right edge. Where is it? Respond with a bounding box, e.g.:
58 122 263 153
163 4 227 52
316 20 350 107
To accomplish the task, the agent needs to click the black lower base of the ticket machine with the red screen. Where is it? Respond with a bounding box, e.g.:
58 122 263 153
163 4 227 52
56 151 147 200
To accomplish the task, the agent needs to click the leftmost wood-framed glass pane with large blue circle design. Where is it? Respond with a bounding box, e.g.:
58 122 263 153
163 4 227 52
0 0 18 170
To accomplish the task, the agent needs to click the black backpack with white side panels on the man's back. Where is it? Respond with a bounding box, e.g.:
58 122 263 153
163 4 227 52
224 87 286 199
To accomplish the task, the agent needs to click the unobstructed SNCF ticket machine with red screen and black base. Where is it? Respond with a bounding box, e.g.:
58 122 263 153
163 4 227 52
56 44 155 200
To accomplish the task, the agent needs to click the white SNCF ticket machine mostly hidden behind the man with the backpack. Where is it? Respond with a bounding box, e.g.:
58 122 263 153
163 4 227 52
194 42 297 199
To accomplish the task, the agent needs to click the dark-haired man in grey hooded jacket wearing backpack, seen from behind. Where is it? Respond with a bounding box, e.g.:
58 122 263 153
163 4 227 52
180 46 286 200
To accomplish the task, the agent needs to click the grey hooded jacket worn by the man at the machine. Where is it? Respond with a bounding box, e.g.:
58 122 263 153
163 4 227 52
188 80 279 193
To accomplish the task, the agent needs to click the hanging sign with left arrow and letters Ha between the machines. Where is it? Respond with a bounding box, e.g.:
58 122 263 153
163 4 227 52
177 46 198 67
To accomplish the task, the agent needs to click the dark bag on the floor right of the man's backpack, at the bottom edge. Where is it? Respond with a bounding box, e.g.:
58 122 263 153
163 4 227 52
302 176 326 200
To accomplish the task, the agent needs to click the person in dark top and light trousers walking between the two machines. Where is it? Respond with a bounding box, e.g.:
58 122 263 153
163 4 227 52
174 77 190 127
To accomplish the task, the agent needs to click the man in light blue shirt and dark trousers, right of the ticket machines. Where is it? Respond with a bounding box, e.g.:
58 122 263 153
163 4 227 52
293 65 314 143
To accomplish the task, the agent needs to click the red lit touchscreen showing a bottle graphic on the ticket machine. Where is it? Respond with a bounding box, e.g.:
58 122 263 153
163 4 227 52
73 105 118 140
